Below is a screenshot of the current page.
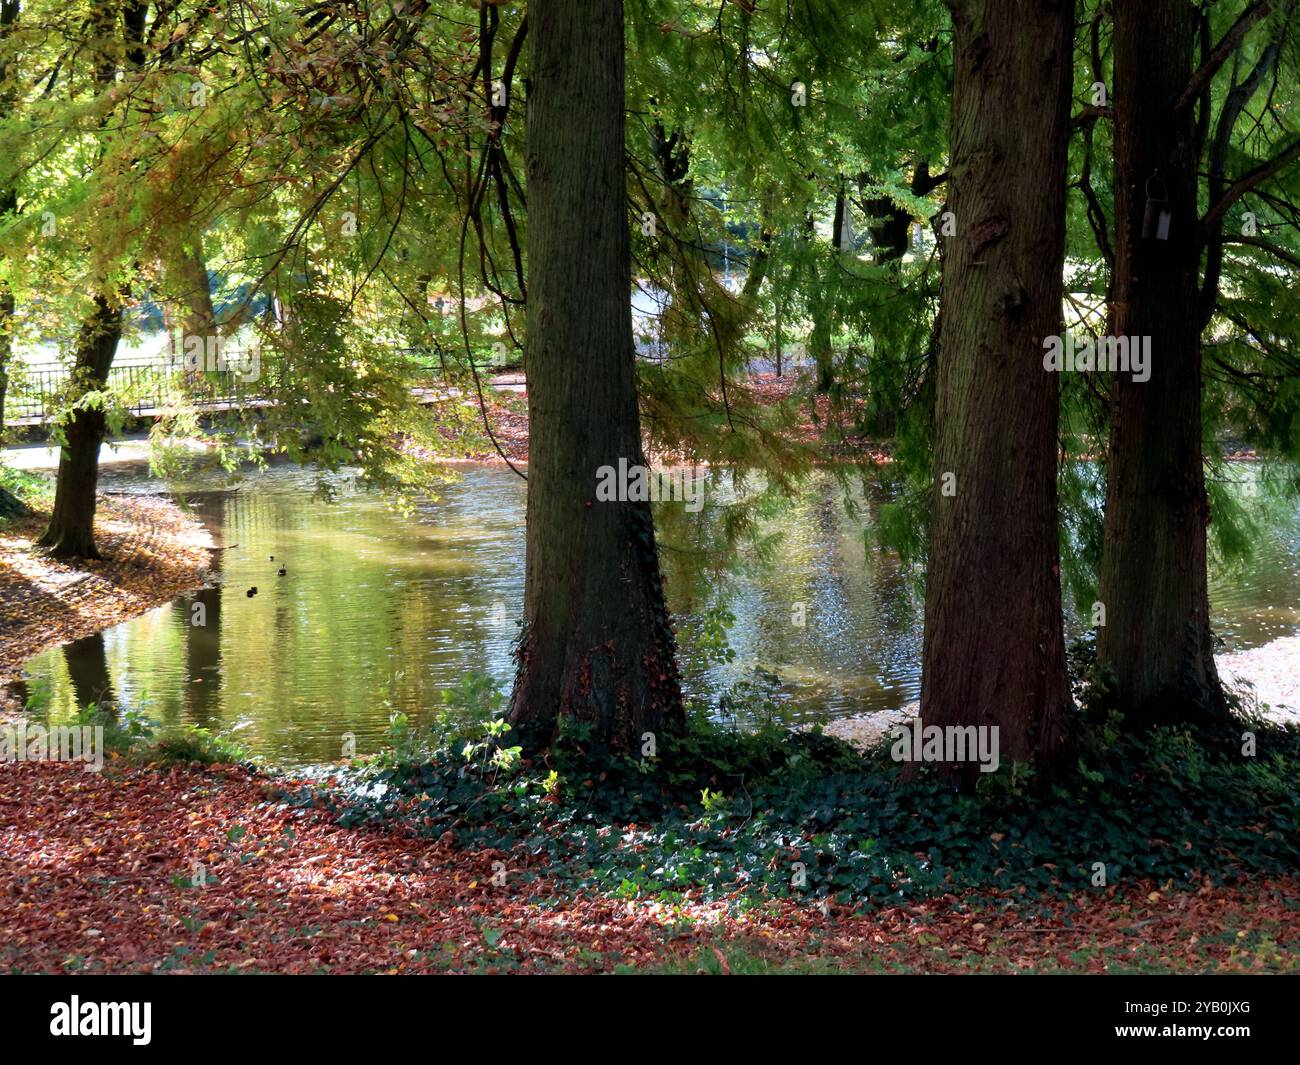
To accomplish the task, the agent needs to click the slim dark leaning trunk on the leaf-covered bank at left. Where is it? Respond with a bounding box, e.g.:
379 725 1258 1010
36 293 122 558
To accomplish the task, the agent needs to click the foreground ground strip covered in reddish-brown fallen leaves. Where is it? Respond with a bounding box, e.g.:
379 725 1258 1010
0 763 1300 973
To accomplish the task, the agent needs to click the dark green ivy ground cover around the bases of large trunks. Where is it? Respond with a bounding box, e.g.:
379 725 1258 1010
290 715 1300 905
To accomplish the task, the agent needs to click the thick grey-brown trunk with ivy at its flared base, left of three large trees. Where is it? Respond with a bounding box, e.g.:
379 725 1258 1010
510 0 683 750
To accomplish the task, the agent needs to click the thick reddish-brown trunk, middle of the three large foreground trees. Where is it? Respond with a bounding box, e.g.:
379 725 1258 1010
920 0 1074 784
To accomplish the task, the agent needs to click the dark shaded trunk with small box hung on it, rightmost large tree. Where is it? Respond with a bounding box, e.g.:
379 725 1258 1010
1097 0 1223 728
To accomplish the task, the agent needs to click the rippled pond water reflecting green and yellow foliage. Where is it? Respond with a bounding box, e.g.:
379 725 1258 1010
27 466 1300 763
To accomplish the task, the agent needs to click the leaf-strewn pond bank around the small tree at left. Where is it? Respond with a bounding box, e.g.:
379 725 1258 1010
0 495 213 689
